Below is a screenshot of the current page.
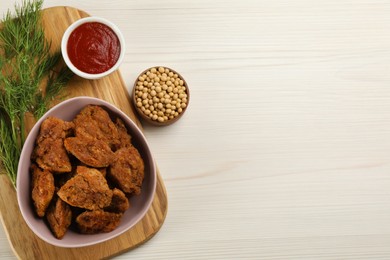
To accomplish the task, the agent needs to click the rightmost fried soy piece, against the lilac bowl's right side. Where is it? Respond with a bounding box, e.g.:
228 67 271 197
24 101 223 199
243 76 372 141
108 146 145 195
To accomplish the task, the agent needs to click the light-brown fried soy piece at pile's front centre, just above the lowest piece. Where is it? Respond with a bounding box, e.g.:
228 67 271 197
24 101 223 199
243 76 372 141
57 166 112 210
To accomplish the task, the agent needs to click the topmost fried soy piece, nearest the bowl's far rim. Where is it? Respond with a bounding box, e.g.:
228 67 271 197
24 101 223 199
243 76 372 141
73 105 119 148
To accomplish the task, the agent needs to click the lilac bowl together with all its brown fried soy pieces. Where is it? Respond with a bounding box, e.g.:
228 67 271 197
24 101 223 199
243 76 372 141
16 97 156 248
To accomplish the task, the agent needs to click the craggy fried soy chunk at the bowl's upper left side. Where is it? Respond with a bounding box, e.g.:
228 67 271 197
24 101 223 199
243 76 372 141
32 117 74 173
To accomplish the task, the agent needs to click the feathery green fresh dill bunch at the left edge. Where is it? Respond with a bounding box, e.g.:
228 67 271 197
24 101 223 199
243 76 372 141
0 0 73 185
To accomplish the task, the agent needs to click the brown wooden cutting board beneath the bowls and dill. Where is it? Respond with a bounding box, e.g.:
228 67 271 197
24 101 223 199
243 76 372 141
0 7 168 259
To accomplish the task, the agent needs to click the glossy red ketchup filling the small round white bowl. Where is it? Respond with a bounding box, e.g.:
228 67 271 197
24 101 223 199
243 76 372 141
67 22 121 74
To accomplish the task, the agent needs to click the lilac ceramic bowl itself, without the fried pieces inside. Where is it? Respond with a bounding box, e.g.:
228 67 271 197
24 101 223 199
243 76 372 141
16 97 156 248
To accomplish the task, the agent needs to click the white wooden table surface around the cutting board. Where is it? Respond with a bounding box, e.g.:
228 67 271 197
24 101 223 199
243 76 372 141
0 0 390 259
